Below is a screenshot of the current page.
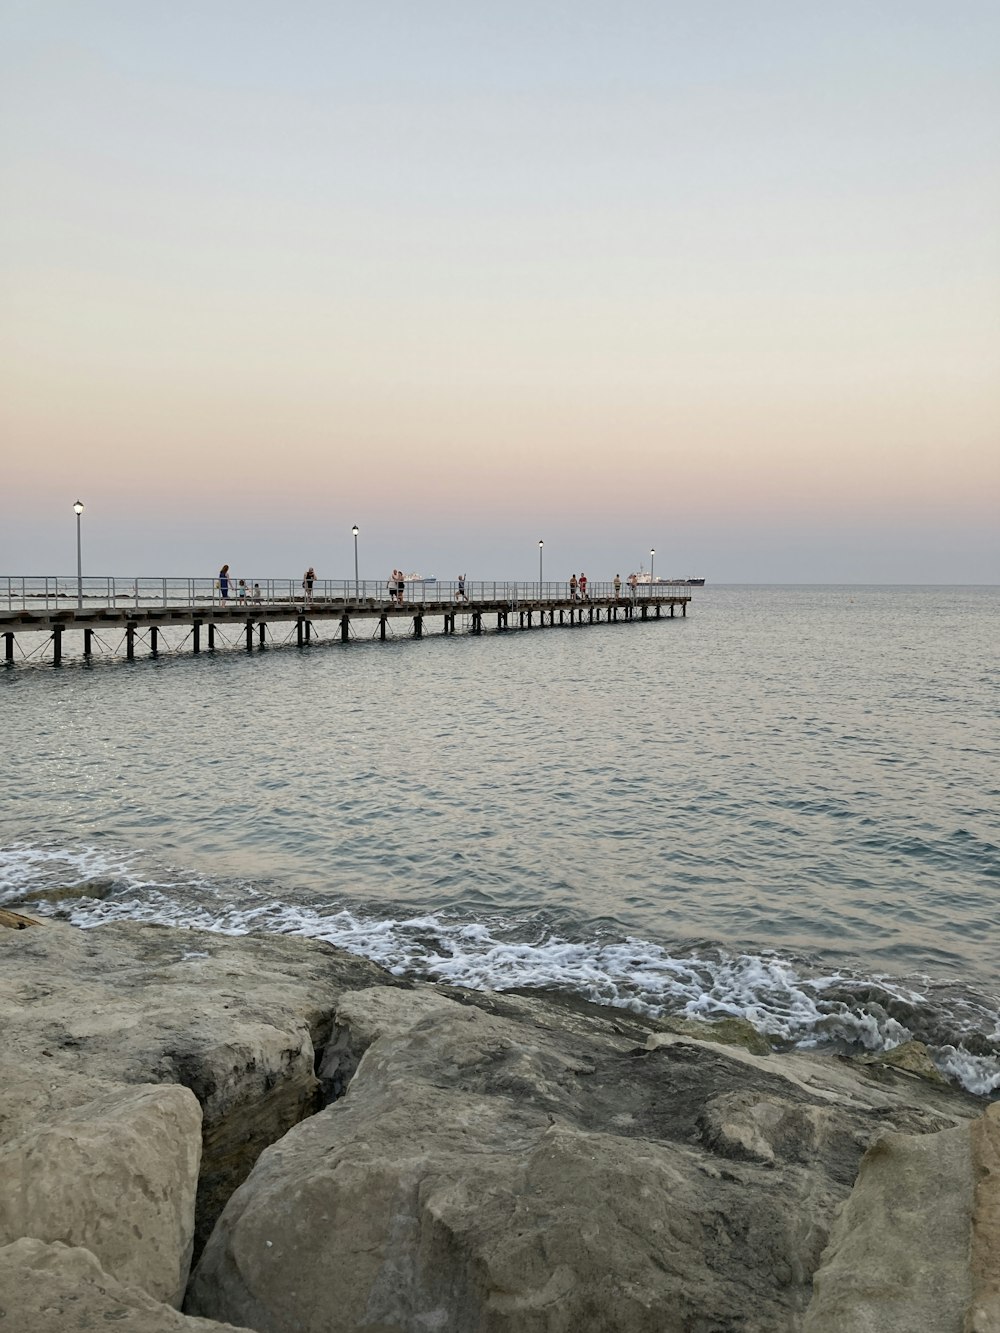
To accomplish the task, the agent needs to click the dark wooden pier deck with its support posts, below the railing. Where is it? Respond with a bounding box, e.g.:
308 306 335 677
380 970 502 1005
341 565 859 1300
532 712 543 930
0 584 691 667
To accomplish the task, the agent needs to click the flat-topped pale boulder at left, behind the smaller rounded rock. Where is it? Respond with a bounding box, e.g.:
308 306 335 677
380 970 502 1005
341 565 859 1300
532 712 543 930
0 921 408 1250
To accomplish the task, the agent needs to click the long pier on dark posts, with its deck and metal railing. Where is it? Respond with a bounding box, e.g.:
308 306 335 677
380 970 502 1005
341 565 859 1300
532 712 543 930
0 576 691 667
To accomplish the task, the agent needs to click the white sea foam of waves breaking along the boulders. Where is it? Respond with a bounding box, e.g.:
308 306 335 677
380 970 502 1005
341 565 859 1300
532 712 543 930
0 848 1000 1096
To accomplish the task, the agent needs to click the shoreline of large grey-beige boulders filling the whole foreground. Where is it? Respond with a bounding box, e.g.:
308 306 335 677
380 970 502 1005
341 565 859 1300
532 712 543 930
0 912 1000 1333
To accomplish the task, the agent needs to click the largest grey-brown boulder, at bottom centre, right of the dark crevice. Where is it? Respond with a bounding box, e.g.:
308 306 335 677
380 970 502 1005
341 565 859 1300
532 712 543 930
187 988 972 1333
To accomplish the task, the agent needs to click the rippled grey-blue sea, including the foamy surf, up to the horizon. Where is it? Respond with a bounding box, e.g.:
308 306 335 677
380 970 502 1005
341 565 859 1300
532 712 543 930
0 584 1000 1096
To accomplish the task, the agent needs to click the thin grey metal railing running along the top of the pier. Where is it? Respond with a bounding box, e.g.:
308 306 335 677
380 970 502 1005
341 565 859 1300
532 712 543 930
0 575 691 611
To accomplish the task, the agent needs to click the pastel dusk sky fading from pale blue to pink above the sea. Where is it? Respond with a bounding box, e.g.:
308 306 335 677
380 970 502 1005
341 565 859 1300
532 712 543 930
0 0 1000 583
